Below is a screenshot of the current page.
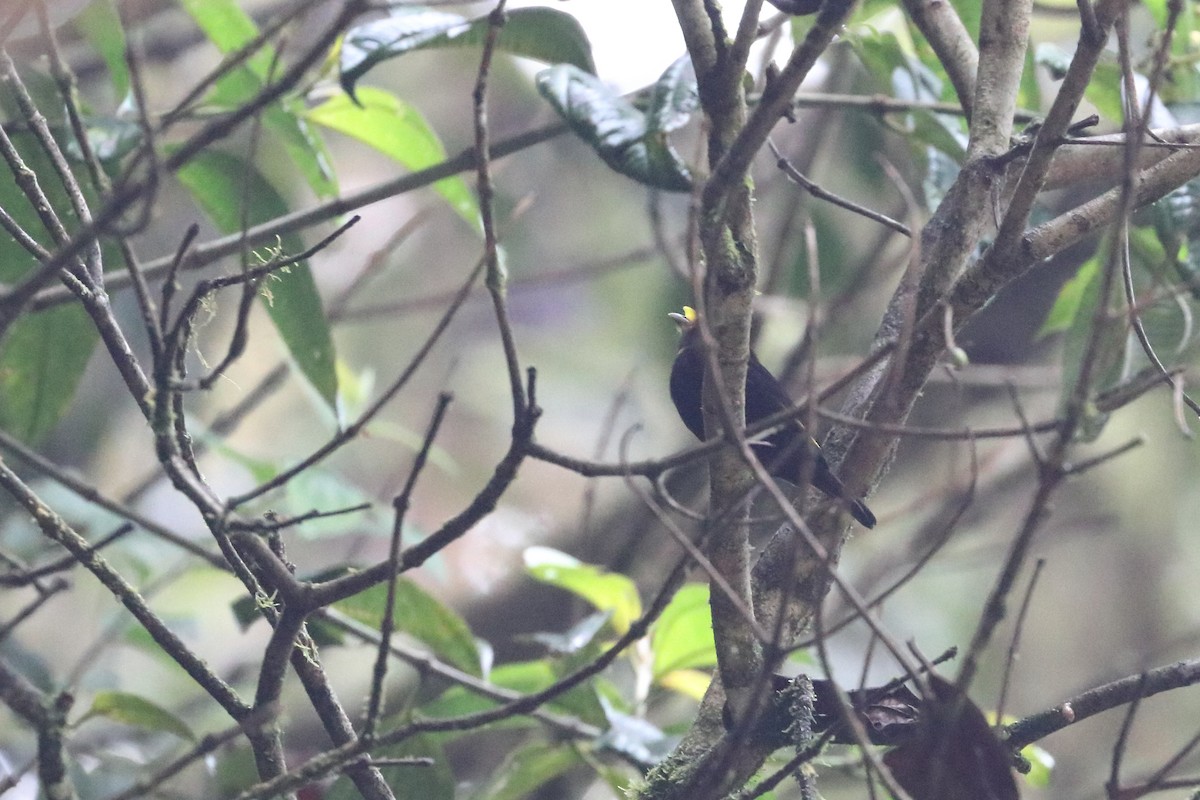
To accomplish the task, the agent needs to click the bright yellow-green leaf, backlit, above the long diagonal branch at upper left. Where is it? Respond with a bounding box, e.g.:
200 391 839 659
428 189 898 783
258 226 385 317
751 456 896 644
307 86 480 230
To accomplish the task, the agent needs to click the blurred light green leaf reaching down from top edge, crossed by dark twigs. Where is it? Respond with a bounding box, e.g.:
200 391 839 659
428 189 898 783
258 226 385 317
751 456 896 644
181 0 337 197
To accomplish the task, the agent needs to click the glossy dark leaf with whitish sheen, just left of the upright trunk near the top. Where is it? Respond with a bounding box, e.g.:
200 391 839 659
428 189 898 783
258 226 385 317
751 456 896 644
536 64 691 192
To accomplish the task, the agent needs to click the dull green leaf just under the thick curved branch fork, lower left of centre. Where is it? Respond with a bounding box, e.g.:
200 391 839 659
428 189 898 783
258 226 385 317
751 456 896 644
334 578 482 675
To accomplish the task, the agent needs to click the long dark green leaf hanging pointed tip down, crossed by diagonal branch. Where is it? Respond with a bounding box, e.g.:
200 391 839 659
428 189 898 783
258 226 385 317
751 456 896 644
176 150 337 409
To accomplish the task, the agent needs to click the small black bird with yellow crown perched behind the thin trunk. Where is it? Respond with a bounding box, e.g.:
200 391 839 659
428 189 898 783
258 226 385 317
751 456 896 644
667 306 876 528
